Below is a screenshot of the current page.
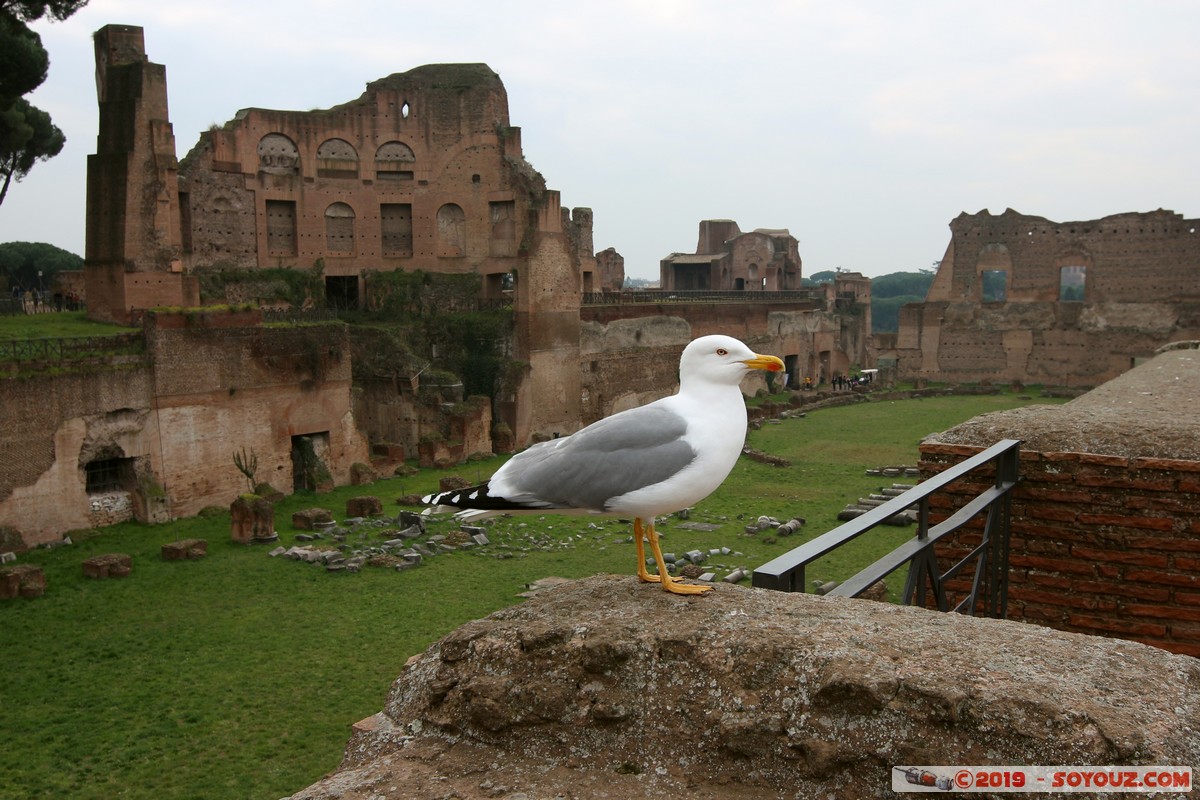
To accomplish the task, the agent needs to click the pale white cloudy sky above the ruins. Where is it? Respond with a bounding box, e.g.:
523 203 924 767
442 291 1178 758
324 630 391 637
0 0 1200 278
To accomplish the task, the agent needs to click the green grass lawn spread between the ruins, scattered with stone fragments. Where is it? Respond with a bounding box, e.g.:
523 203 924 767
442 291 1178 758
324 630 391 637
0 395 1070 800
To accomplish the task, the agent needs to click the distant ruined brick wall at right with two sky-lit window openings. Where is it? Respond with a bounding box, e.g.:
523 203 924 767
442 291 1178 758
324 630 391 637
880 209 1200 386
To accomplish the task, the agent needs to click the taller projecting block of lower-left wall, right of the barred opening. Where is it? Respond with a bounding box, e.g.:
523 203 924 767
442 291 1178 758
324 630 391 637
146 311 368 516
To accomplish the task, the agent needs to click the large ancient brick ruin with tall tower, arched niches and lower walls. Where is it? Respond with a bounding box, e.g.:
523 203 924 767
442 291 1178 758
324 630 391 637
0 25 870 546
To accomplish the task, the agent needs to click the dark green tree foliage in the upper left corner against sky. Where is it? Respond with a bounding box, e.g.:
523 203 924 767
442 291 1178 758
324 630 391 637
0 0 88 204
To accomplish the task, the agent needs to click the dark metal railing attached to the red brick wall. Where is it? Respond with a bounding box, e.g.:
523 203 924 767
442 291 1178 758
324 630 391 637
754 439 1021 618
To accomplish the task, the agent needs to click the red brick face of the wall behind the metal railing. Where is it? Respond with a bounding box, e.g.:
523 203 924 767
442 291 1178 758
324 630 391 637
920 444 1200 656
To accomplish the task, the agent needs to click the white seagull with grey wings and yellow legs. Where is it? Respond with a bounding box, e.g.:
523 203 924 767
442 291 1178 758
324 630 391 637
421 335 784 595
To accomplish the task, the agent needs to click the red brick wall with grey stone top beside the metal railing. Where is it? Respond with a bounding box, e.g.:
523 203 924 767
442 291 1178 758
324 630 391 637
920 348 1200 656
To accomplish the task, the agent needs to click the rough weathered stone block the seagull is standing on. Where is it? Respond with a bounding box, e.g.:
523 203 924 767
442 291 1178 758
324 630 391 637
283 576 1200 800
